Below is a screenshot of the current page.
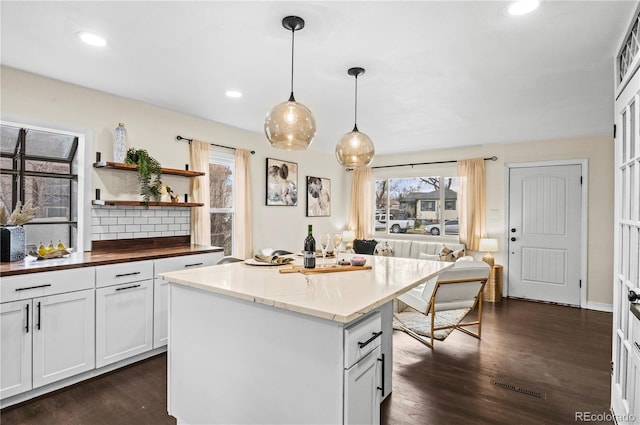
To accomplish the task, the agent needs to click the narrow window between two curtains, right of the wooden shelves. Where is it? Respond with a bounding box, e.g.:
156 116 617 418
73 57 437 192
209 149 235 255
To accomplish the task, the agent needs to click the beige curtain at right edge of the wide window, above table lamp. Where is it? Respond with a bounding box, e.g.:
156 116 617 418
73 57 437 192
458 158 486 251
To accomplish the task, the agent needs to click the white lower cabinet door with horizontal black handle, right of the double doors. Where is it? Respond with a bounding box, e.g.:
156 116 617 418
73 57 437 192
96 279 153 367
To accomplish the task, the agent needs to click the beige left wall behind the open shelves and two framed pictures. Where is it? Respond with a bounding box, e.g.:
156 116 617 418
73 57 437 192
0 67 350 250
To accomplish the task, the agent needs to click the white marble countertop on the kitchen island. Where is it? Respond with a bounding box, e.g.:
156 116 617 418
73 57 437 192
159 254 454 323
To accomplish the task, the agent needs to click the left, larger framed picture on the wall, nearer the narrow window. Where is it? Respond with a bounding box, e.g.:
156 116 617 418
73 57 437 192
267 158 298 206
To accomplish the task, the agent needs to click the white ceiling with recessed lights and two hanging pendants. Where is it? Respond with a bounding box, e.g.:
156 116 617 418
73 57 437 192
0 0 636 154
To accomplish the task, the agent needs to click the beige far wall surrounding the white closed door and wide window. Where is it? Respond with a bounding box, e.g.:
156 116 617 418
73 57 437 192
374 135 614 308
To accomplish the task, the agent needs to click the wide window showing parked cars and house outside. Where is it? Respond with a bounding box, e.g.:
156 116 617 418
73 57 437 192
374 176 458 236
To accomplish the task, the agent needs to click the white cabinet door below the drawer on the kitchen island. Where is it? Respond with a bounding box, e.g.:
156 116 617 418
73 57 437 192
344 347 380 424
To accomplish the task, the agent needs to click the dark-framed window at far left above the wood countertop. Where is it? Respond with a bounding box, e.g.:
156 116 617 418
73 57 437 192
0 124 79 252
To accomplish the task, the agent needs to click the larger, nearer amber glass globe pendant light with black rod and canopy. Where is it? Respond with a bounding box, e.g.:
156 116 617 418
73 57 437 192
264 16 316 150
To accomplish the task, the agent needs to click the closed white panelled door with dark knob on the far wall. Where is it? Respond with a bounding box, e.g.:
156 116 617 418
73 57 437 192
508 164 582 305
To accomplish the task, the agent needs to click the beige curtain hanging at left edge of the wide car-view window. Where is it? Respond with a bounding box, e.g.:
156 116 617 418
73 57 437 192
349 167 373 239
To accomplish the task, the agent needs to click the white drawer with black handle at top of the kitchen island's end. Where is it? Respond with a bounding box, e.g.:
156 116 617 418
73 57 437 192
344 312 382 368
